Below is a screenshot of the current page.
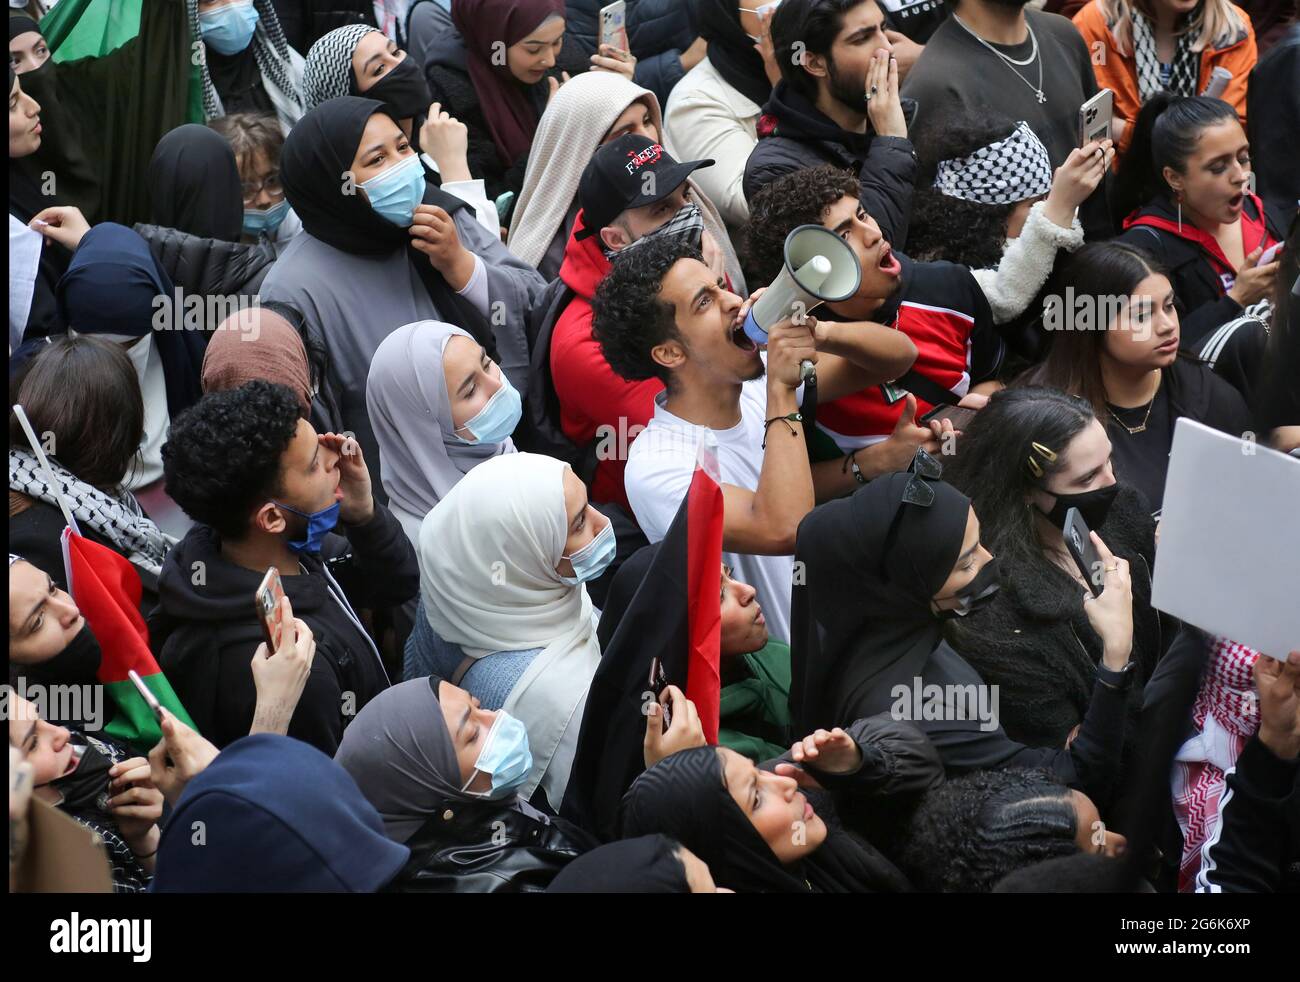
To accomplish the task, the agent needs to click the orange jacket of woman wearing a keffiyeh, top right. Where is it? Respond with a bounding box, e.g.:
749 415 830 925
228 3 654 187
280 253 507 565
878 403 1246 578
1074 0 1256 153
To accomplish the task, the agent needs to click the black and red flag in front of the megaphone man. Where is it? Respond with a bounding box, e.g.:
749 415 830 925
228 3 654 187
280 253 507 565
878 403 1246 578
560 433 723 840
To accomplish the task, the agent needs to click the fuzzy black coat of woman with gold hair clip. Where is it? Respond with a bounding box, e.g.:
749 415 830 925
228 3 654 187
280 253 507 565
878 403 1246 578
948 485 1173 748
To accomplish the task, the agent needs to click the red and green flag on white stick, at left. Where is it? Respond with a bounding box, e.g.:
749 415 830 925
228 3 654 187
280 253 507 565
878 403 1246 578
62 528 194 754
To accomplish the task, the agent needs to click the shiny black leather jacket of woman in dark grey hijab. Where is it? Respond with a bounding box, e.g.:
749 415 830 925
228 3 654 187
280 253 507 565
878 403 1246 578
389 800 599 894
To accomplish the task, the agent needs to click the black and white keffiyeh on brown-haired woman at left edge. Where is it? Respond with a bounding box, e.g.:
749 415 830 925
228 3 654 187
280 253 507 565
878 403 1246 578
9 447 176 576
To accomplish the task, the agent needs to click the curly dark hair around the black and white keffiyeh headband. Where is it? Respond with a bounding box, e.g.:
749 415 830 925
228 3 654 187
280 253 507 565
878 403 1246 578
907 108 1015 269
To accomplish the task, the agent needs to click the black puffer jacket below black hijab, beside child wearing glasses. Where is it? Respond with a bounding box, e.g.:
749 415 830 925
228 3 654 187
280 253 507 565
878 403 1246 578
135 225 276 309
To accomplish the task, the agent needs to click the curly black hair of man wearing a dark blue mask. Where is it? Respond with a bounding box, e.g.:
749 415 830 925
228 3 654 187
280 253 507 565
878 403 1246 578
163 380 300 540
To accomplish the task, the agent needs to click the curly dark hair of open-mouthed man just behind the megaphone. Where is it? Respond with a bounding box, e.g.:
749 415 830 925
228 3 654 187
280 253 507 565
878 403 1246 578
742 164 858 287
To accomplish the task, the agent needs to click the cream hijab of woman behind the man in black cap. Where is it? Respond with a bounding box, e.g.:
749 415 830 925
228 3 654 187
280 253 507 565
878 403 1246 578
506 72 745 294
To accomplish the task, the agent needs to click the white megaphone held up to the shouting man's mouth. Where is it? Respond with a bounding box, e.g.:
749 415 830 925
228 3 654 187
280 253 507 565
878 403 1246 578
745 225 862 378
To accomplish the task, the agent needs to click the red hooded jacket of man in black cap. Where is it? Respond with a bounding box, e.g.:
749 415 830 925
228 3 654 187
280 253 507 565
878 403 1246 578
551 212 663 515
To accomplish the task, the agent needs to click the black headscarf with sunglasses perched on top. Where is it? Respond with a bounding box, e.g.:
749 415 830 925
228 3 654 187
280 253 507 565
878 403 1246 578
790 472 970 734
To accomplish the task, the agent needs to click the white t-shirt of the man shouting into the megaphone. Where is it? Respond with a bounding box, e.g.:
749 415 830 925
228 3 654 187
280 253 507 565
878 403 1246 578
623 378 794 644
